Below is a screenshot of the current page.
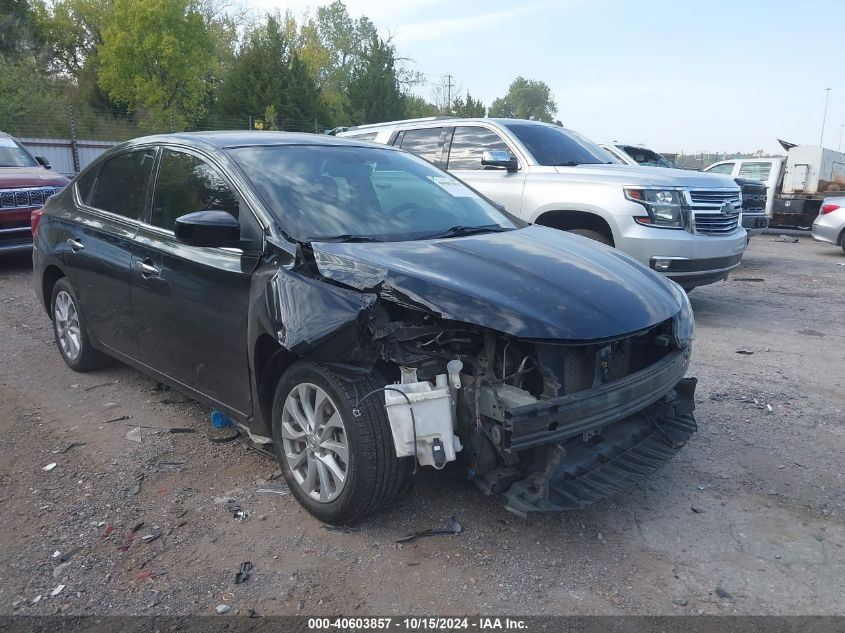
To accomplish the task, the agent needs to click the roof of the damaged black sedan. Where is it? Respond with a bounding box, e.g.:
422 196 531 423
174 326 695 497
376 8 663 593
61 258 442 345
123 130 392 149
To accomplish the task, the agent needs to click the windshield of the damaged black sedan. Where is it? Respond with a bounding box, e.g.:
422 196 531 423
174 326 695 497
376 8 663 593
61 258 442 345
229 145 517 242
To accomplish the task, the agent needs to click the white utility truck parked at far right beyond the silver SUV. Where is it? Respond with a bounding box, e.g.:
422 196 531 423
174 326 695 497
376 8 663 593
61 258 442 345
704 141 845 228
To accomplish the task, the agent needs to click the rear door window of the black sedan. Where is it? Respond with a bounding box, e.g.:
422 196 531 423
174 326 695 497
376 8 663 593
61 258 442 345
90 149 155 220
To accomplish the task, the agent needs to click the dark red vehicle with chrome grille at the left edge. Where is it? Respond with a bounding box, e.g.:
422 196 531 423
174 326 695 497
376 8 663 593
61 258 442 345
0 132 69 254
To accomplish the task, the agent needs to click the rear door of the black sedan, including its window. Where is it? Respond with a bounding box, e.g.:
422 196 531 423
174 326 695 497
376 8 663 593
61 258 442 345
63 147 156 358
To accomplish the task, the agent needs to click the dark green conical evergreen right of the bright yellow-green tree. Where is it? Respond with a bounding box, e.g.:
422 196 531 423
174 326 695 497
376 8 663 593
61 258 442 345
218 13 322 130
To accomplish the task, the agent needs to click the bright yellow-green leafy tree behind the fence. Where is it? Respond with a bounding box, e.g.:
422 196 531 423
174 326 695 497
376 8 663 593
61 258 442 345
98 0 216 129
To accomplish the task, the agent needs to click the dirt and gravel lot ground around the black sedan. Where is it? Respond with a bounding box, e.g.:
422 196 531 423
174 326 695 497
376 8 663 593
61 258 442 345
0 235 845 615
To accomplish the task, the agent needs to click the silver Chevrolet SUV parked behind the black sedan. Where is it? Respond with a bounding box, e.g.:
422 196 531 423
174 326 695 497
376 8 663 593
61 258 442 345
339 118 746 290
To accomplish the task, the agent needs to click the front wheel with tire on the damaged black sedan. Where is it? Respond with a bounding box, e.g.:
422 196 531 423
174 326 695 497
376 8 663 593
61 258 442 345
273 361 412 524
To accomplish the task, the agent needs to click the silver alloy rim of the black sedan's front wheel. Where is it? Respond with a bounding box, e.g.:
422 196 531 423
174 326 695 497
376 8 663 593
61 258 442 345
281 383 349 503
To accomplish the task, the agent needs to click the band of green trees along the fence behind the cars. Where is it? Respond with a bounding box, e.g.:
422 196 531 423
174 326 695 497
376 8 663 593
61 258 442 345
0 0 568 140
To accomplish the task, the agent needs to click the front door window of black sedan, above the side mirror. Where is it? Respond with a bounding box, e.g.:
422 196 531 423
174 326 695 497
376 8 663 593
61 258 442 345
150 148 239 231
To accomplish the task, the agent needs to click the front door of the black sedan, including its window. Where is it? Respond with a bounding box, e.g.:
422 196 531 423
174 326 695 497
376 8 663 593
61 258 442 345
132 147 255 415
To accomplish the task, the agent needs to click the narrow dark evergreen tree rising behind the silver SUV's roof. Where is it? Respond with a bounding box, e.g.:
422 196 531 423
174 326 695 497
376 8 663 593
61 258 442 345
347 35 405 124
